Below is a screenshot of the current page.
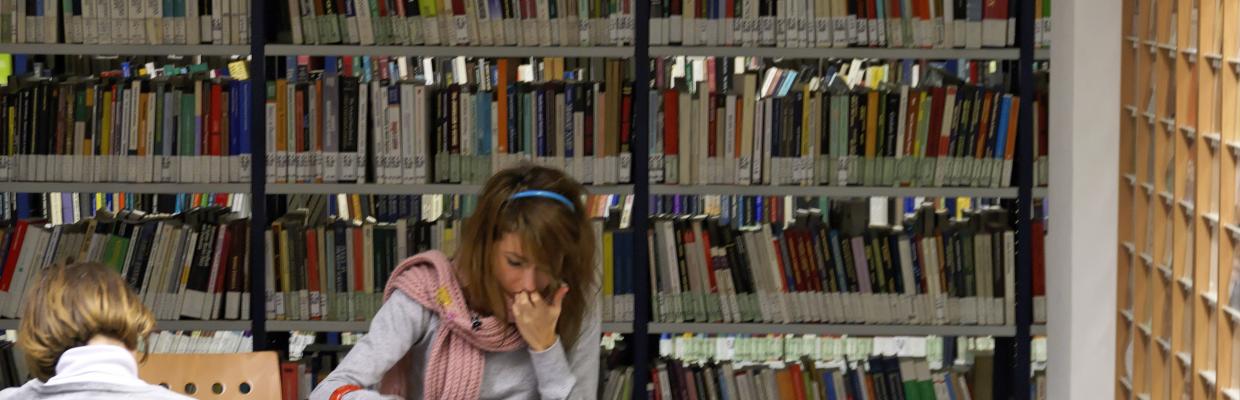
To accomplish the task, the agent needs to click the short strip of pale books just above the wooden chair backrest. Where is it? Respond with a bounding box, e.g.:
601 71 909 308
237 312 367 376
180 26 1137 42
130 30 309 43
138 331 254 354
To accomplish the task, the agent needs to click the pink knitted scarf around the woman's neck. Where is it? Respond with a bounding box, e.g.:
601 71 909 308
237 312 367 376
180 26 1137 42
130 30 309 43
379 250 526 400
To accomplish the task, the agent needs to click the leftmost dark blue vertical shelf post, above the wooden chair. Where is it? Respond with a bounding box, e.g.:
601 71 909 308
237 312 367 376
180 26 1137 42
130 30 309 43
249 1 268 352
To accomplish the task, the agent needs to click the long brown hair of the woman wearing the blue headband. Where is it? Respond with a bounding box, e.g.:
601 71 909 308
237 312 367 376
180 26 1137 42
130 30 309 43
454 163 595 348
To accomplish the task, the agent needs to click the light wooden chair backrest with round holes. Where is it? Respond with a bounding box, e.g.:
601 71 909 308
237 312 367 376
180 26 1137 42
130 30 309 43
138 352 281 400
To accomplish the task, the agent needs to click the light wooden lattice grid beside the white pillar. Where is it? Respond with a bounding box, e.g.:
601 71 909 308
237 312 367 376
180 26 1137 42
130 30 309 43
1115 0 1240 399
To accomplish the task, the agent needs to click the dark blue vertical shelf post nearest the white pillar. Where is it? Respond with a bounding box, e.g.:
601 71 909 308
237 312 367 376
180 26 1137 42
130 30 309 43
1012 1 1034 400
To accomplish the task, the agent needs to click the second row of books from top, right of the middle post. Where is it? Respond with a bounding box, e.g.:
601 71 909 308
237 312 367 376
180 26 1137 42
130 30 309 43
650 57 1048 187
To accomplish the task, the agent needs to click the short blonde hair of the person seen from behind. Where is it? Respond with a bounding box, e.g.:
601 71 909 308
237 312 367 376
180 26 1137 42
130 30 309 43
17 263 155 381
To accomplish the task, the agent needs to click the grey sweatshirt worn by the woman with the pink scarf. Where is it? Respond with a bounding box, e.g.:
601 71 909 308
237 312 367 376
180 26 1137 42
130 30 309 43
310 291 601 400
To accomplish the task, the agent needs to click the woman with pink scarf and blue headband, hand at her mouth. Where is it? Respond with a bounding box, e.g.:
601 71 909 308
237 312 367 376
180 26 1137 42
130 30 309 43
310 165 600 400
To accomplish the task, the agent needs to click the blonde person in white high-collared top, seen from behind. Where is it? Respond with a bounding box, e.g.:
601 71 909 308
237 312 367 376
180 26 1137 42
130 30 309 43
0 263 190 400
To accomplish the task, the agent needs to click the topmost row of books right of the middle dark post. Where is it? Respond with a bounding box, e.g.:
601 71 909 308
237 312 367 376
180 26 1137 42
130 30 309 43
650 0 1050 48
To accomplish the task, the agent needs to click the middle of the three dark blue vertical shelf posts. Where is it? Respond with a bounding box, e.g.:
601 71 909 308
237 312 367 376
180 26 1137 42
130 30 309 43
630 0 653 399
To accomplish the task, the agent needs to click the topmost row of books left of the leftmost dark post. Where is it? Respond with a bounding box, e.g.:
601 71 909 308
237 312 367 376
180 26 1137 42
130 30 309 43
0 0 250 45
